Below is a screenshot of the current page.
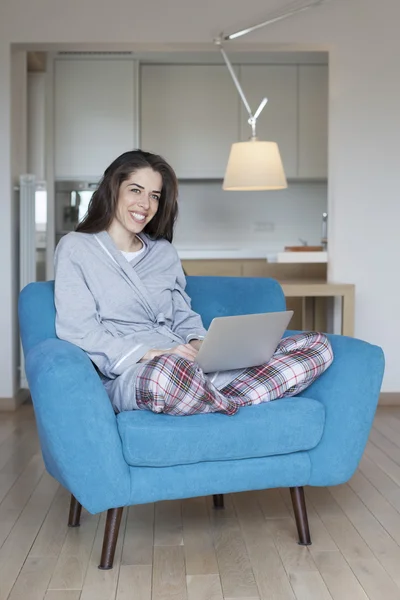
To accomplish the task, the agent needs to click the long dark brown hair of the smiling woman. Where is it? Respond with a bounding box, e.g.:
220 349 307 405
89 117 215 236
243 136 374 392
76 150 178 242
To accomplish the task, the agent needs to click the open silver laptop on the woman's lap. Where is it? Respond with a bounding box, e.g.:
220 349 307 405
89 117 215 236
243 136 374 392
196 310 293 373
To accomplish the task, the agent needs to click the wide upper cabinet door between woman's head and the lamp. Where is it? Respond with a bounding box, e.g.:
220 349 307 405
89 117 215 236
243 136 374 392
141 65 239 178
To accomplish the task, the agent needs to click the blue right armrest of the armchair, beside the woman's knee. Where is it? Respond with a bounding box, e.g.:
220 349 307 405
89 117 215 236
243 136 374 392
290 335 385 486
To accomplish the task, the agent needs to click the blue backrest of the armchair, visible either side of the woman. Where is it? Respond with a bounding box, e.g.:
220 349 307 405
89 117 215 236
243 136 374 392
18 276 286 356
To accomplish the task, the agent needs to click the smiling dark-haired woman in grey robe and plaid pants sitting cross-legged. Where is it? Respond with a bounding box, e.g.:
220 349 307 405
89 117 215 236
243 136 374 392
55 150 333 415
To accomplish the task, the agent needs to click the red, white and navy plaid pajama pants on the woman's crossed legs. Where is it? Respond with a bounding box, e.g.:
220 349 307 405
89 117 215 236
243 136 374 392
135 332 333 415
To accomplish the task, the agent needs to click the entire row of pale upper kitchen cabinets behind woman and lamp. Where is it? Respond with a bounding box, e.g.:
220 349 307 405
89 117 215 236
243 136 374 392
54 58 328 180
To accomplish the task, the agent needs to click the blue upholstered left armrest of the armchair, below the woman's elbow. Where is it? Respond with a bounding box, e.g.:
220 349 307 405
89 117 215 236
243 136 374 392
25 338 130 513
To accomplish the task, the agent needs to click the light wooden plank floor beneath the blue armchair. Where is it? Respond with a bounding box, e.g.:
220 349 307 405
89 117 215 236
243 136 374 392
0 405 400 600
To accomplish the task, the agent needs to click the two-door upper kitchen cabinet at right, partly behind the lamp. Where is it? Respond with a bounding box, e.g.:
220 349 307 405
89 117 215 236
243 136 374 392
239 65 328 179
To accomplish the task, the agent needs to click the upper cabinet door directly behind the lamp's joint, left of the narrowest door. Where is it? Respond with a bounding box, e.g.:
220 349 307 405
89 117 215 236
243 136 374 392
240 65 297 177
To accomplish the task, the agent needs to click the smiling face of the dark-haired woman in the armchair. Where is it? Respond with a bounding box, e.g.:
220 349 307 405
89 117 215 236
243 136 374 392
114 167 162 234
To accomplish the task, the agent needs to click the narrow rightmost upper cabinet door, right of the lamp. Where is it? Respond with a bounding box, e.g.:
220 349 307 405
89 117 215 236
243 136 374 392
298 65 328 178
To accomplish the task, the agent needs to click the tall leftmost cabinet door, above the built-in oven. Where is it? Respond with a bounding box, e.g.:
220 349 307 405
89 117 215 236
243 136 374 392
54 59 135 179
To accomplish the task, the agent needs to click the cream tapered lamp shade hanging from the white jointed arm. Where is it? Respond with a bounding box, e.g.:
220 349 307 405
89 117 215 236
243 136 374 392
222 138 287 191
